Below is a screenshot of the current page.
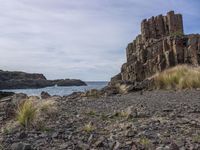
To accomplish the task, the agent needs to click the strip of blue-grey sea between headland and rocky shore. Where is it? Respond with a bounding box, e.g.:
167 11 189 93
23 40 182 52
2 82 108 96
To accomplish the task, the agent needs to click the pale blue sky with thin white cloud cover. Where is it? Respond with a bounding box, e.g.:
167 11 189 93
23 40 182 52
0 0 200 81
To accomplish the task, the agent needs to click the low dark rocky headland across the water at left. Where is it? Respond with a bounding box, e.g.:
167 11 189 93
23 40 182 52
0 70 86 89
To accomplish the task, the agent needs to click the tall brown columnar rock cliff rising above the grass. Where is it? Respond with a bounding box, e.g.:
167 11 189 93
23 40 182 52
111 11 200 85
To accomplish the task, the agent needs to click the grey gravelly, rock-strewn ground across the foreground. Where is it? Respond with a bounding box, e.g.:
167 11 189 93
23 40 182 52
0 90 200 150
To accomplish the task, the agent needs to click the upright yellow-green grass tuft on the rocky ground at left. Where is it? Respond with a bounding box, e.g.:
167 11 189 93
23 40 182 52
17 100 37 127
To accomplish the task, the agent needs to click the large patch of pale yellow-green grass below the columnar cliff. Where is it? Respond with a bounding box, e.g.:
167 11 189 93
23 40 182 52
154 65 200 89
